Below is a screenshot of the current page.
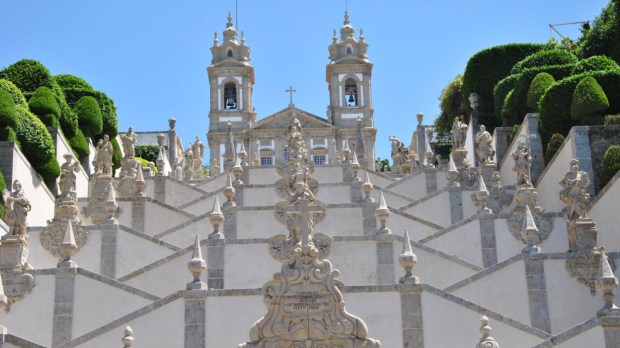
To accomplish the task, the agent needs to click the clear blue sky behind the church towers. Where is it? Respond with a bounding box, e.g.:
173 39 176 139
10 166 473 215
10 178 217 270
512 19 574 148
0 0 608 158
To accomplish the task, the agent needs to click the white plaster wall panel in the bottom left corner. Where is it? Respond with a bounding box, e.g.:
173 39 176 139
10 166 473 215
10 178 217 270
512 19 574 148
0 275 56 347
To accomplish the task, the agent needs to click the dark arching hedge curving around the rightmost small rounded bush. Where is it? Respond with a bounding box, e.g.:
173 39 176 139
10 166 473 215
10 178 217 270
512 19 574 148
540 70 620 144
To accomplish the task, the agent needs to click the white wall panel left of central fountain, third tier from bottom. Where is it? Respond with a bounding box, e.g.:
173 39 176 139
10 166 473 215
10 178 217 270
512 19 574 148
237 210 286 239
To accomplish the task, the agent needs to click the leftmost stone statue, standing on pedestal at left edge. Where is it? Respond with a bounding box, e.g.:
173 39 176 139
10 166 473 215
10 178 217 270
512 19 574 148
2 180 32 236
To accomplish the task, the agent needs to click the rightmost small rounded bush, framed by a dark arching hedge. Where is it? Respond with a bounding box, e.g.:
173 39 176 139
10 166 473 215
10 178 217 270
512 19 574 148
570 76 609 120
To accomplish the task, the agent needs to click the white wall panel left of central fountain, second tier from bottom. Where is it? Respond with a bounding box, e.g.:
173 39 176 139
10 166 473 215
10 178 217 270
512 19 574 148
224 243 281 289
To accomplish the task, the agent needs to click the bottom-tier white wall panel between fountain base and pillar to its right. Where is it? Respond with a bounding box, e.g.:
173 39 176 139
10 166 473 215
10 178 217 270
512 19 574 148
344 292 403 347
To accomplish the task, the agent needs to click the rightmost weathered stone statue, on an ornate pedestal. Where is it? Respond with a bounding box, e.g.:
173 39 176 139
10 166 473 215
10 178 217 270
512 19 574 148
560 159 590 221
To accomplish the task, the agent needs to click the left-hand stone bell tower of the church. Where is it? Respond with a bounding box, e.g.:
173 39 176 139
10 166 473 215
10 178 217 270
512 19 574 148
207 13 256 167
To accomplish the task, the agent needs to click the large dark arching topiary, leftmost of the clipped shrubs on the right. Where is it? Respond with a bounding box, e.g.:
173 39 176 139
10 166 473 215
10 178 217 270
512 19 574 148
463 43 546 117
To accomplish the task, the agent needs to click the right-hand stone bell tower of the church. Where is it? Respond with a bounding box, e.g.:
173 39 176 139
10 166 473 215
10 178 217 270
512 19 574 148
326 12 377 169
